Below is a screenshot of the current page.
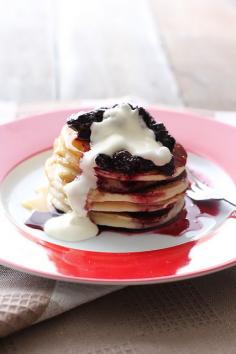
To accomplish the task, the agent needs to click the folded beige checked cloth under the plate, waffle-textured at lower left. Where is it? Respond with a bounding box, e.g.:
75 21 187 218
0 99 232 337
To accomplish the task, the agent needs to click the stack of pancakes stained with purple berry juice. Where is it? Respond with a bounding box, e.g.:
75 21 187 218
45 125 188 229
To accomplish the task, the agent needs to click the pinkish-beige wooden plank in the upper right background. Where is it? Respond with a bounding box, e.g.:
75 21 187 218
150 0 236 110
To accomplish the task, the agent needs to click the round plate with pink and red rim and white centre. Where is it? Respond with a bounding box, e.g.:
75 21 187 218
0 108 236 284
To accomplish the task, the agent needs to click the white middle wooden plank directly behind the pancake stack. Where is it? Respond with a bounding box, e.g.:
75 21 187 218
55 0 181 104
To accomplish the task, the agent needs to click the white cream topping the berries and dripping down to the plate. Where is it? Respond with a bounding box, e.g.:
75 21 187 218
45 104 172 241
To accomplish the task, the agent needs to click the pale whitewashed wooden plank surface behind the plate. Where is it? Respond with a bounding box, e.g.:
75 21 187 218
0 0 236 110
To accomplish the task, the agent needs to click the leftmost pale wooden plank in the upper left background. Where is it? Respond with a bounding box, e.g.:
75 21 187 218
0 0 56 103
